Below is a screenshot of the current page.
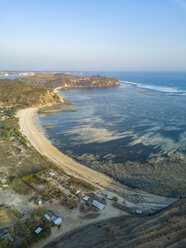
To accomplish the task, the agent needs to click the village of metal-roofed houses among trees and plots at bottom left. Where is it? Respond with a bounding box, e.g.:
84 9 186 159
0 167 128 247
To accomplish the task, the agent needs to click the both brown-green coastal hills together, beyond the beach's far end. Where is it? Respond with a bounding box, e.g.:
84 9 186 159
0 73 120 107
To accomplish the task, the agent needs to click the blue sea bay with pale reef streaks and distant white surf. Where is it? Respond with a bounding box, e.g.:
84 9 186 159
37 72 186 196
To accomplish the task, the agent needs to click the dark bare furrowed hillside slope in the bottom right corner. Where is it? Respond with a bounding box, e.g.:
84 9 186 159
44 198 186 248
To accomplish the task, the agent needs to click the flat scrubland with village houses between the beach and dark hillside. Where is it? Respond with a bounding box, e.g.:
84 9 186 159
0 107 174 248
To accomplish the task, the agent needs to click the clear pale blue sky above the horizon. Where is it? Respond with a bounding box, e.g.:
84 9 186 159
0 0 186 71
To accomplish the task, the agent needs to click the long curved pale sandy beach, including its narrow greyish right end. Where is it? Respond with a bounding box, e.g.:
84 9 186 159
17 105 176 203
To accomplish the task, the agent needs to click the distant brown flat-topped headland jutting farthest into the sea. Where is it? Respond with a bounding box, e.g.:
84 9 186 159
17 73 120 89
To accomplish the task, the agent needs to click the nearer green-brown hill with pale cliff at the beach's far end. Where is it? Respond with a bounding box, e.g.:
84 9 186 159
0 79 60 107
